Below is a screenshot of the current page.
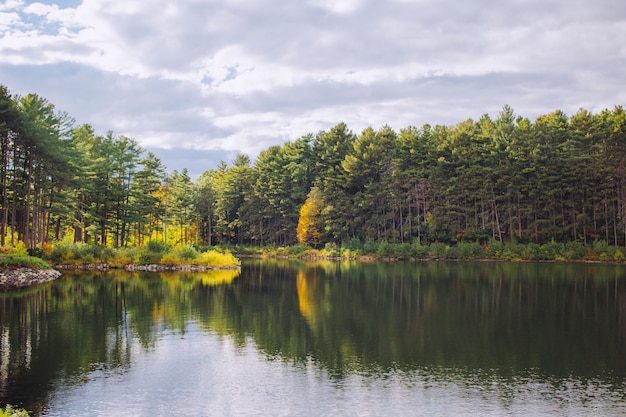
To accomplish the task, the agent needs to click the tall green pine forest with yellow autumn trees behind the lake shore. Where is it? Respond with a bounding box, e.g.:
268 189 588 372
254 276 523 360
0 85 626 248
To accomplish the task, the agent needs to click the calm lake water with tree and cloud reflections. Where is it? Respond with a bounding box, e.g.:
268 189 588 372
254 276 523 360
0 260 626 416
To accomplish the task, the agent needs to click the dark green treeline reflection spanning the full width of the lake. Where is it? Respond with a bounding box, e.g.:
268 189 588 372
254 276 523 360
0 260 626 411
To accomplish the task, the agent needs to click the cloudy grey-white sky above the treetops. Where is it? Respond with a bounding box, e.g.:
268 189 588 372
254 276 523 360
0 0 626 176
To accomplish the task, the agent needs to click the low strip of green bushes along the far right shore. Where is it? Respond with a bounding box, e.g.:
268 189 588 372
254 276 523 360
232 239 626 262
